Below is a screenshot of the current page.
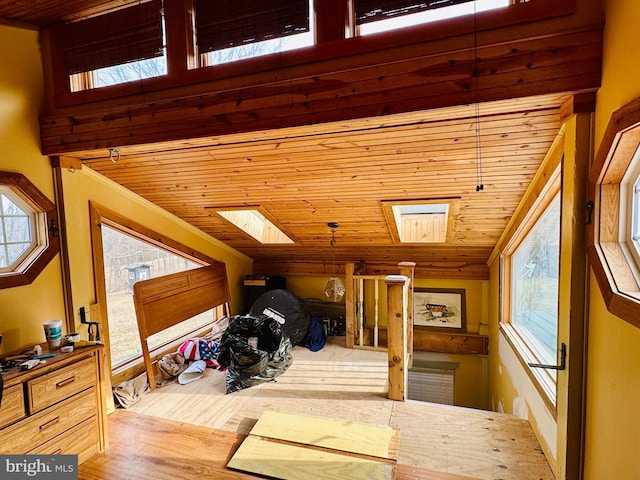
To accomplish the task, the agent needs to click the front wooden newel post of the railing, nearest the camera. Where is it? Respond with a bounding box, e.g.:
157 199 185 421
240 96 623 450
384 275 410 402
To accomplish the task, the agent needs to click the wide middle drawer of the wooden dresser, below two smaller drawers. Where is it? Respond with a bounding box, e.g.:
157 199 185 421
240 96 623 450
0 387 97 454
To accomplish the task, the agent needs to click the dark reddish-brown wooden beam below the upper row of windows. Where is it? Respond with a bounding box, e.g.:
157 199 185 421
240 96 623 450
40 27 602 154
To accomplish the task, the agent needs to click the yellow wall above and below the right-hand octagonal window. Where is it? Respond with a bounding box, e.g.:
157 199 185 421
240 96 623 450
584 0 640 480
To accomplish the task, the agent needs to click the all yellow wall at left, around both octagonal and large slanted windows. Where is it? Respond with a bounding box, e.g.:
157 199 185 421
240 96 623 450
0 26 252 353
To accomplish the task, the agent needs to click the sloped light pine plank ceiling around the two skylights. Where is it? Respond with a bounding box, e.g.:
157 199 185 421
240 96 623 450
78 95 565 278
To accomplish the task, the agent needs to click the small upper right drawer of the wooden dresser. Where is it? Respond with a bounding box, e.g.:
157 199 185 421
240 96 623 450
27 358 98 413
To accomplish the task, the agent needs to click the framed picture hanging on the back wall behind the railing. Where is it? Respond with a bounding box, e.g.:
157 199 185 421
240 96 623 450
413 288 467 332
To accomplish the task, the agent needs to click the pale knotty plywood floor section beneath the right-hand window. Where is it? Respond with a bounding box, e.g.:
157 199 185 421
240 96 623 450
390 401 555 480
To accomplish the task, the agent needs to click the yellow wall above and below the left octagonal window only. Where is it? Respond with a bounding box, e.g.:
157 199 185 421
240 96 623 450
0 26 64 354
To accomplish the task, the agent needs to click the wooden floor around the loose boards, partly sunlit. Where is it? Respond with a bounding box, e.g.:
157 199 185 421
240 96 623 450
79 339 554 480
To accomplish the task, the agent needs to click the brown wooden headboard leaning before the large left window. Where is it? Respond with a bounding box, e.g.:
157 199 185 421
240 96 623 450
133 263 230 390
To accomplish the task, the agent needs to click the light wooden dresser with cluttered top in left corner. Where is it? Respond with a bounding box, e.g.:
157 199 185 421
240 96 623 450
0 344 107 463
